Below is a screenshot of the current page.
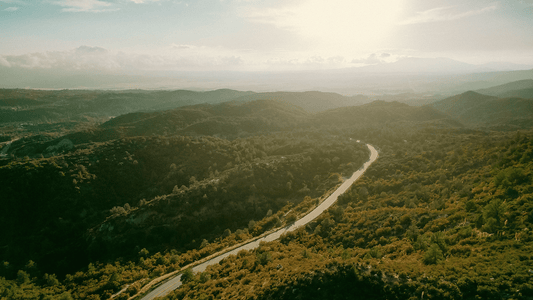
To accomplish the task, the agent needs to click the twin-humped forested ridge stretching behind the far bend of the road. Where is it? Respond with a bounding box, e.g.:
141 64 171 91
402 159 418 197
1 100 463 157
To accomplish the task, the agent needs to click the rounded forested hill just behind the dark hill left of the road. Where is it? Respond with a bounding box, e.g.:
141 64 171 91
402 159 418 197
1 100 309 157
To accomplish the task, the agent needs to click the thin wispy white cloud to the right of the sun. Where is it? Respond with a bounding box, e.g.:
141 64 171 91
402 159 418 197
400 4 498 25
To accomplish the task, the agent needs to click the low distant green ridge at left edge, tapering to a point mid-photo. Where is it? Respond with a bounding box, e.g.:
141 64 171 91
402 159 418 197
0 89 251 123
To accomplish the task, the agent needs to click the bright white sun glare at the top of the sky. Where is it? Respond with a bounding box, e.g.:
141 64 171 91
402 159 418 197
285 0 402 52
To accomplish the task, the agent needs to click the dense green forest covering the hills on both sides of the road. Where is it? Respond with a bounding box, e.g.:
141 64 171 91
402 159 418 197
0 84 533 299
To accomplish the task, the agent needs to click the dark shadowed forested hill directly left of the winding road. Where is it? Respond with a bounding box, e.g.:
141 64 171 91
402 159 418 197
0 132 368 274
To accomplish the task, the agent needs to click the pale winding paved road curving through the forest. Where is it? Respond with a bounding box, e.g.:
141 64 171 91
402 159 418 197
141 144 378 300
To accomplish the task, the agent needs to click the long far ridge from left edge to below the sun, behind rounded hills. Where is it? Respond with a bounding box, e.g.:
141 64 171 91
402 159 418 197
0 89 361 124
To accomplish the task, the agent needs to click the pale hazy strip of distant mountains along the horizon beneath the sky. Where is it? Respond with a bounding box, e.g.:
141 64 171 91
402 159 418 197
0 57 533 95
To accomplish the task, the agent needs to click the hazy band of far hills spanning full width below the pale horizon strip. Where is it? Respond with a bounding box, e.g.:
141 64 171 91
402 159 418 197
0 78 533 140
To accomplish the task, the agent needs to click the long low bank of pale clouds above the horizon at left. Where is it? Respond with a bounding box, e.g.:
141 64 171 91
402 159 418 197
0 43 380 74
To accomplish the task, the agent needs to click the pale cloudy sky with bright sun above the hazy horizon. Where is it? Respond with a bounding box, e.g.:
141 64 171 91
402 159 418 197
0 0 533 74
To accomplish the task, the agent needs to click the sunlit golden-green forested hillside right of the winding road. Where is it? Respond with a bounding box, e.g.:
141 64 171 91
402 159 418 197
162 131 533 299
